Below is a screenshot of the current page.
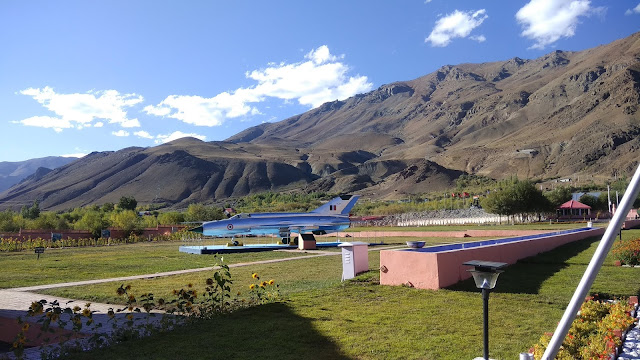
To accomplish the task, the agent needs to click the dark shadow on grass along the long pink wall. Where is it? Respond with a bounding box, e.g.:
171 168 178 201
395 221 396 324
448 237 601 294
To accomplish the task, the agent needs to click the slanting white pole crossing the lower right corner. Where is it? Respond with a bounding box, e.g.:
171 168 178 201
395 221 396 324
542 165 640 360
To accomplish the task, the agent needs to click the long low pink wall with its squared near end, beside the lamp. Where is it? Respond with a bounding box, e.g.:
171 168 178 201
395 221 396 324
380 228 605 290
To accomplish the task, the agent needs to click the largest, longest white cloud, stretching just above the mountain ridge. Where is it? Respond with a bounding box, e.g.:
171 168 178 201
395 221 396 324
144 45 373 126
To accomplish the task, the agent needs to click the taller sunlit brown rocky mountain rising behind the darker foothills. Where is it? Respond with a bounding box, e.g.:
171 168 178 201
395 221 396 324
228 33 640 178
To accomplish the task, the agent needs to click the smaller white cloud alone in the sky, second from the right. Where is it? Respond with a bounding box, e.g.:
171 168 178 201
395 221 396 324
424 9 488 47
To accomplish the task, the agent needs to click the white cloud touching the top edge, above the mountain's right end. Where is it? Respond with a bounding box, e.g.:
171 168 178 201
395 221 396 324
516 0 605 49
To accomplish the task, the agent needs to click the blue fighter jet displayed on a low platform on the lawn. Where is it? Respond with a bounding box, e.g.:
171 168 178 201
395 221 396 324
191 195 360 238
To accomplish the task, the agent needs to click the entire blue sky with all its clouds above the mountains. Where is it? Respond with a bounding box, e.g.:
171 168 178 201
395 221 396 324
0 0 640 161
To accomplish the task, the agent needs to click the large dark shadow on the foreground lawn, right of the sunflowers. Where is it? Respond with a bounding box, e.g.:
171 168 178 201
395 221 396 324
70 303 350 360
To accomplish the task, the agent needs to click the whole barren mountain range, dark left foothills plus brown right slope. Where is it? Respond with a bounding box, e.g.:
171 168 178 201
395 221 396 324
0 33 640 209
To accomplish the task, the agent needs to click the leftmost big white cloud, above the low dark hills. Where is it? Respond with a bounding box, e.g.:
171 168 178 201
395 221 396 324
20 86 144 129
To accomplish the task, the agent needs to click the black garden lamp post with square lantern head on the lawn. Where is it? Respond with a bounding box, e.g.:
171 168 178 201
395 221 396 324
462 260 507 360
